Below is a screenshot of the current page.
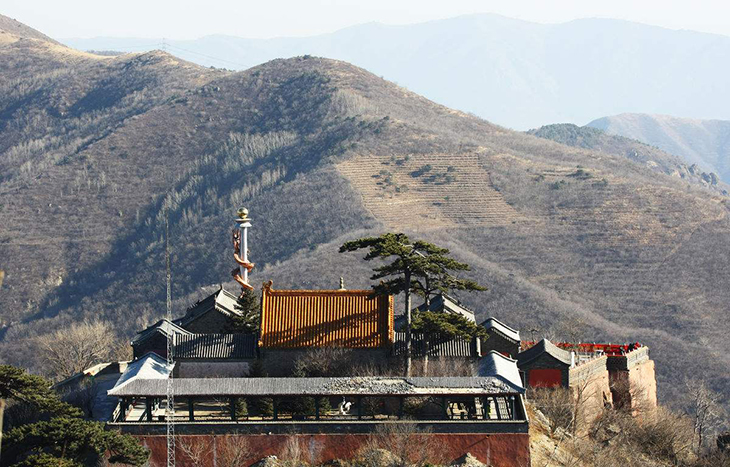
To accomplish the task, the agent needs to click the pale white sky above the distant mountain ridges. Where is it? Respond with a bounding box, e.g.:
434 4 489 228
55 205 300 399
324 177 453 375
5 0 730 39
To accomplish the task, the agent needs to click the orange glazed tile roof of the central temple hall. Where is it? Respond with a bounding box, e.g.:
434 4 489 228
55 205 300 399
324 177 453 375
259 281 393 348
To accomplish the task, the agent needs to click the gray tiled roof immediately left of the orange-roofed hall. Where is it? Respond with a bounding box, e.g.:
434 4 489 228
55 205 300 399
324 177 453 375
173 334 258 359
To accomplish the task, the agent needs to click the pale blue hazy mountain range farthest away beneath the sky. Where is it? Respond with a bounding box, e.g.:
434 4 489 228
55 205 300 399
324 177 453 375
63 14 730 130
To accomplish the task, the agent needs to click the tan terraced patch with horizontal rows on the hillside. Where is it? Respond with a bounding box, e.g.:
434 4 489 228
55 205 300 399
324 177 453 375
337 153 525 230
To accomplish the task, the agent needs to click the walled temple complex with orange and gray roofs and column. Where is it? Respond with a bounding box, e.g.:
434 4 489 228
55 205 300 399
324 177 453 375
58 209 656 466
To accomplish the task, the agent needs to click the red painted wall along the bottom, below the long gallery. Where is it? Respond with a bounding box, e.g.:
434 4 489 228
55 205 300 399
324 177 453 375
137 433 530 467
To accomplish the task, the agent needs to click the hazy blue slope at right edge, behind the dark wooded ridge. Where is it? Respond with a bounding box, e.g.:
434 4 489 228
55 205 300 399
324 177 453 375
587 114 730 182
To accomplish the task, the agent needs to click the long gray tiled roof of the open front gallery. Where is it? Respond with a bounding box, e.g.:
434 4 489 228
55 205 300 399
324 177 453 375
109 376 524 397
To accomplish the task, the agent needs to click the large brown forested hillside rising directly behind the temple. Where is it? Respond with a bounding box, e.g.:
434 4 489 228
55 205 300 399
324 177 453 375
0 15 730 410
